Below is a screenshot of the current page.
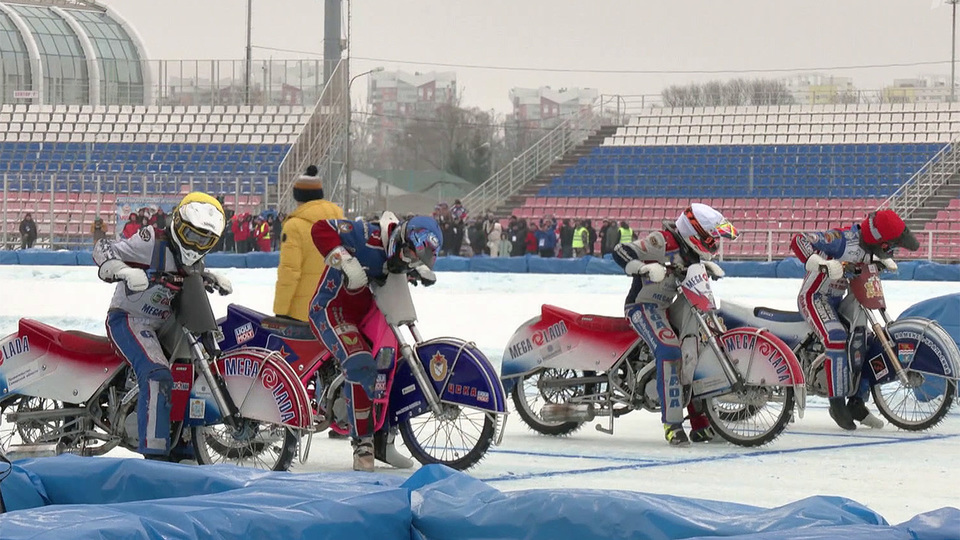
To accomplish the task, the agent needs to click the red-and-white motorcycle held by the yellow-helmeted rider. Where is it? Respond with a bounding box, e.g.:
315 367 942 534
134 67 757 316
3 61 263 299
0 274 313 470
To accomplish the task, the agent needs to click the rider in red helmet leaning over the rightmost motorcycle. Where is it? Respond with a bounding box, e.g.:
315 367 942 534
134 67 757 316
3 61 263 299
790 210 920 430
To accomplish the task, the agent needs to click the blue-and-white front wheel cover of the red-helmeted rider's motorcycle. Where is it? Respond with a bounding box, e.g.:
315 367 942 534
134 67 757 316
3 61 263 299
863 317 960 384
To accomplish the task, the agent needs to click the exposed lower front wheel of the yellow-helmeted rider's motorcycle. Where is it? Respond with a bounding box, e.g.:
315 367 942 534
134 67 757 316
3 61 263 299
191 420 298 471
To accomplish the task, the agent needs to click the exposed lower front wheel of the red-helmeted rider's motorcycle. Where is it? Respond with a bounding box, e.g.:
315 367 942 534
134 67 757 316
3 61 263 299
872 369 957 431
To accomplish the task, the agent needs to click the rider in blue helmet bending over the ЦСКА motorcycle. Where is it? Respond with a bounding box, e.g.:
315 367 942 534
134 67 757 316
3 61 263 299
309 212 443 471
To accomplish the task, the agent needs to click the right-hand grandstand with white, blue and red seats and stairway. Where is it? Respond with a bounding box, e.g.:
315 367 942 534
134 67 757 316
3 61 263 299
464 103 960 261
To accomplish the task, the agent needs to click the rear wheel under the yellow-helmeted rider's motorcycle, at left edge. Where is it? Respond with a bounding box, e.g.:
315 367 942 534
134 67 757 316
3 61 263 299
0 396 76 452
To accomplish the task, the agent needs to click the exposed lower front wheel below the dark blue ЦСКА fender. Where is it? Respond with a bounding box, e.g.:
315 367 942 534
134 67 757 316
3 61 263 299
400 403 496 471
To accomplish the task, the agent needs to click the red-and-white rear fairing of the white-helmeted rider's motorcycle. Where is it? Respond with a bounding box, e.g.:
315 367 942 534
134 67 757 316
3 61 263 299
501 304 639 387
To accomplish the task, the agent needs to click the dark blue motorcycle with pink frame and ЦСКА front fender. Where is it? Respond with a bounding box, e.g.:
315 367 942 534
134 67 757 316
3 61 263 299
219 274 506 470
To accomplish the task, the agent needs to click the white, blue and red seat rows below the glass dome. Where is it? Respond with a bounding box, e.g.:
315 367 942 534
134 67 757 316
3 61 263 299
0 104 311 247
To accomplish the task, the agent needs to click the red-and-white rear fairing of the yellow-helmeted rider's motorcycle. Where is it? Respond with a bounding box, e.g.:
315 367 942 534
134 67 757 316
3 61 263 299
0 319 124 404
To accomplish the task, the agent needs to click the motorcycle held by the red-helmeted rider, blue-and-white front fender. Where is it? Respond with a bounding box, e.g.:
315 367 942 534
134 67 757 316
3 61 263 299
720 263 960 431
